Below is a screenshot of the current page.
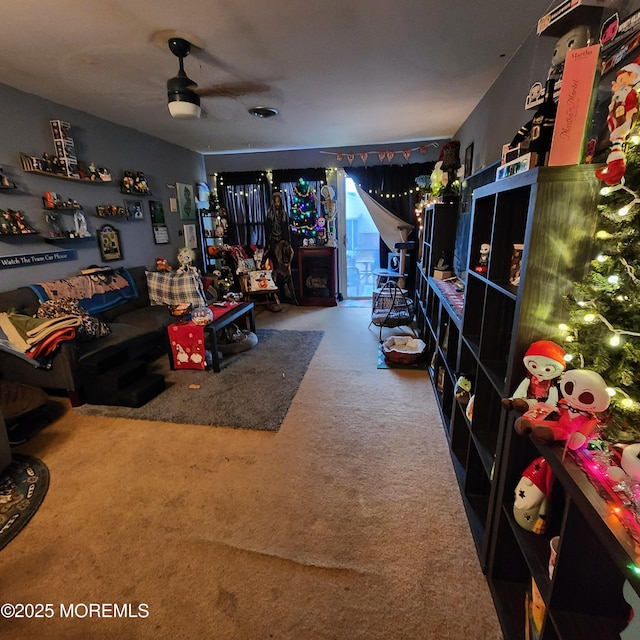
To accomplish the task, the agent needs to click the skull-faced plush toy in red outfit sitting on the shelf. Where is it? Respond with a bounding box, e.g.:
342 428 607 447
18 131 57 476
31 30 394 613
514 369 610 450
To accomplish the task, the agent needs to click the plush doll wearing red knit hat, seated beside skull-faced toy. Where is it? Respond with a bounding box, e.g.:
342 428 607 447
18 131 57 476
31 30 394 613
502 340 567 413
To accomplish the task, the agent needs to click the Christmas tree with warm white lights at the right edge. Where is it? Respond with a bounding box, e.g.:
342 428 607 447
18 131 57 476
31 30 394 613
560 138 640 441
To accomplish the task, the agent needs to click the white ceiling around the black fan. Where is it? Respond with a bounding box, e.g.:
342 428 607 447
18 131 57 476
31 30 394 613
0 0 556 153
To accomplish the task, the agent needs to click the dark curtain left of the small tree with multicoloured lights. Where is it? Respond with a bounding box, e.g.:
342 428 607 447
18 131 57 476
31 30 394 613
218 171 271 245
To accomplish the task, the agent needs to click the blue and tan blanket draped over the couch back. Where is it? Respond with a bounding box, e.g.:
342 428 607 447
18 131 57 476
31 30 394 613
28 268 140 314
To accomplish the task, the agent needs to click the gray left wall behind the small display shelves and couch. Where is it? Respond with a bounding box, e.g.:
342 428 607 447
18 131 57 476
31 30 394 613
0 85 206 290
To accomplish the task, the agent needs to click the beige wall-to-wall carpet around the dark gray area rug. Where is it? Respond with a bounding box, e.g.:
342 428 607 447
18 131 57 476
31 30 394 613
0 306 501 640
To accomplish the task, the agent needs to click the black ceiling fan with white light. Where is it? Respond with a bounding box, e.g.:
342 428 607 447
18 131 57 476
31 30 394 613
167 37 269 118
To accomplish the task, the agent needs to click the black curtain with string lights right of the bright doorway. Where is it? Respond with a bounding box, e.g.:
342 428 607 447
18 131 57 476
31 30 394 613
344 162 435 276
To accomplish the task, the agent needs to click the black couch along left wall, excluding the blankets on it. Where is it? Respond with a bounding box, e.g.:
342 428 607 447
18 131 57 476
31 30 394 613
0 267 175 405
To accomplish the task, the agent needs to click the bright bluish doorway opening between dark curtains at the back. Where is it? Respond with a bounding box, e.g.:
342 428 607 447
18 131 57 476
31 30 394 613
338 171 380 300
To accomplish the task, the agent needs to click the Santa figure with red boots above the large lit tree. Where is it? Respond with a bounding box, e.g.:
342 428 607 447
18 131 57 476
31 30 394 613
596 58 640 185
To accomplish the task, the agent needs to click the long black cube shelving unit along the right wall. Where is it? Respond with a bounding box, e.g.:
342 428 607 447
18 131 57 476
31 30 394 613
415 165 640 640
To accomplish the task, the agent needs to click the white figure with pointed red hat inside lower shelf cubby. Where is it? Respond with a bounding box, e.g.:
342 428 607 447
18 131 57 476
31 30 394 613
513 457 553 534
